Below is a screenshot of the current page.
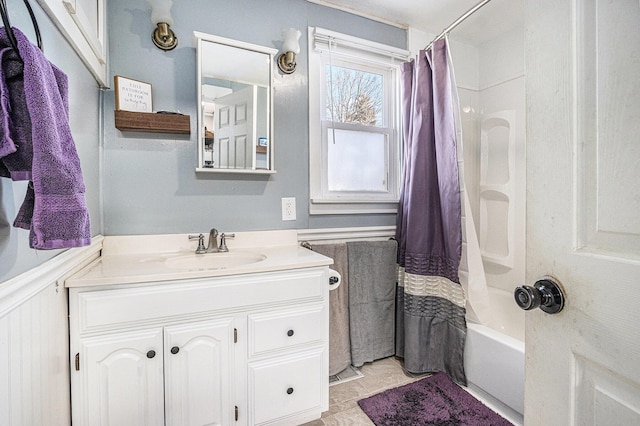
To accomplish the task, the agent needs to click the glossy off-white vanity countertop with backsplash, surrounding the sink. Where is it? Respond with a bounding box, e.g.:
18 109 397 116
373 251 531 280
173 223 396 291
65 230 333 287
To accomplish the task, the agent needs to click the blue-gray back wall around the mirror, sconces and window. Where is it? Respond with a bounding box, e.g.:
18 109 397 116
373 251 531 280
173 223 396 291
103 0 406 235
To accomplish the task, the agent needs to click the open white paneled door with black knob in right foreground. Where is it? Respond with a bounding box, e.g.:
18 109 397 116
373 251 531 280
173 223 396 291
525 0 640 426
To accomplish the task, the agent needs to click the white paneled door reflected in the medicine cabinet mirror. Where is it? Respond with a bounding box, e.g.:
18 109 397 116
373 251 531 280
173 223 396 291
213 86 258 169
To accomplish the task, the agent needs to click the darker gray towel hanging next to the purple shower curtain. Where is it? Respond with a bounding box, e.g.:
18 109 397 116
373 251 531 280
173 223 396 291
347 240 397 367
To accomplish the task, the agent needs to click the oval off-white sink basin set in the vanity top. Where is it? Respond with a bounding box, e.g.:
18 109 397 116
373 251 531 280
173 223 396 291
165 253 267 271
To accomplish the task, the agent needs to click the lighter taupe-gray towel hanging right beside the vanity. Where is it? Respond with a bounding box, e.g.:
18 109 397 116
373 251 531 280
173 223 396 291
311 243 351 376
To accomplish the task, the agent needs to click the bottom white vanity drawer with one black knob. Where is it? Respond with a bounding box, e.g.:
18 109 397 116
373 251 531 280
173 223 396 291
249 350 328 425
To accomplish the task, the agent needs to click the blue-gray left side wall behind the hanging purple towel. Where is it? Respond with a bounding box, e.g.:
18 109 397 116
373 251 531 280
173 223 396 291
0 1 102 283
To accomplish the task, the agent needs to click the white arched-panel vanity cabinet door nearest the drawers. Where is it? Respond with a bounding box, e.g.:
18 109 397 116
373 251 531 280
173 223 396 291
165 318 235 426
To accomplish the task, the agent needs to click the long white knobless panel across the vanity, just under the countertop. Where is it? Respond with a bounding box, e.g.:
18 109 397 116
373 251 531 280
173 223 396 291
69 268 326 333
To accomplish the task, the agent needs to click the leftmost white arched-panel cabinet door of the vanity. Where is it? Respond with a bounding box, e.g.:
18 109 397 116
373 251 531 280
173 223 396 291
73 328 164 426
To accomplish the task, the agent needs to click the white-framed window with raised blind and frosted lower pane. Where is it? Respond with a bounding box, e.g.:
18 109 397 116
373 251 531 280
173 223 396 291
309 28 407 214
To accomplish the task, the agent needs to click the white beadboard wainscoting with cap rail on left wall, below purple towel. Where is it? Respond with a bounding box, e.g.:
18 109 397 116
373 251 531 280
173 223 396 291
0 236 103 426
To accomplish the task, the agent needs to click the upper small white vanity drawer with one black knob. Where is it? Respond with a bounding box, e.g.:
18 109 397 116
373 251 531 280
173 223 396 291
248 304 328 357
